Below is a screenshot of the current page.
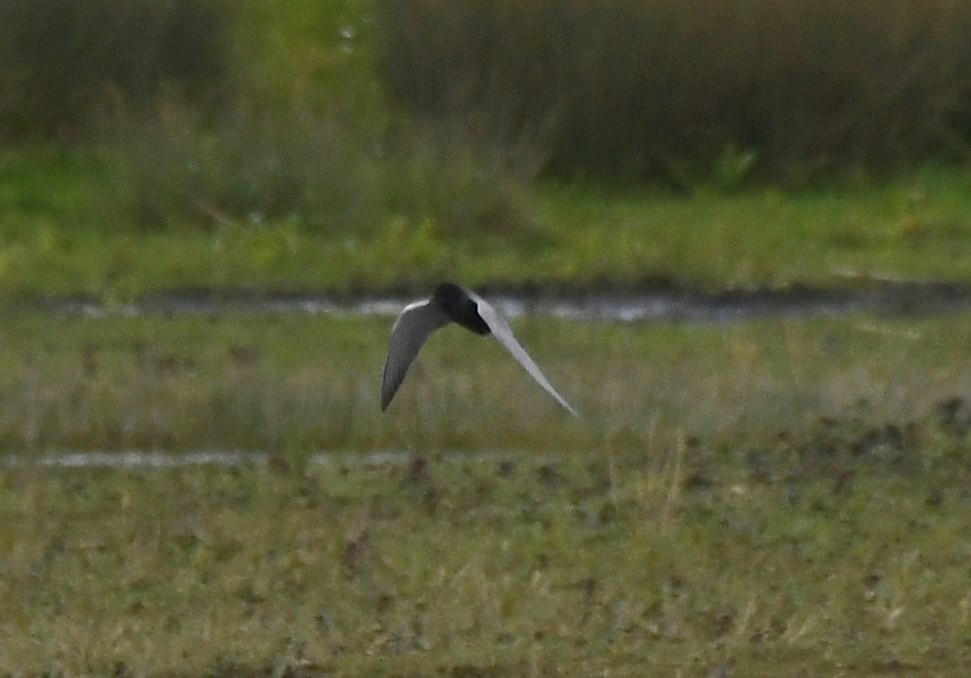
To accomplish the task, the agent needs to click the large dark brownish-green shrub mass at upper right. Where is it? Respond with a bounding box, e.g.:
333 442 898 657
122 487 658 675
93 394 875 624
377 0 971 183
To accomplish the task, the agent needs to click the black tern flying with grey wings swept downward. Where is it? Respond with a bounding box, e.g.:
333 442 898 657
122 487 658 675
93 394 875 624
381 282 579 417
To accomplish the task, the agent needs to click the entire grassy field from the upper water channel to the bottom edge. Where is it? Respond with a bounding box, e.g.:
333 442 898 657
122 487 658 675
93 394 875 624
0 309 971 675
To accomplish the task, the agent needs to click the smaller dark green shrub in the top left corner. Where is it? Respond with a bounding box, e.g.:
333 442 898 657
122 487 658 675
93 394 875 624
0 0 233 137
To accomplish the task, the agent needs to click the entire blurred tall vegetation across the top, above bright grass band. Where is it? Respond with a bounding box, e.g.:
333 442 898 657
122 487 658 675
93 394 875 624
0 0 971 282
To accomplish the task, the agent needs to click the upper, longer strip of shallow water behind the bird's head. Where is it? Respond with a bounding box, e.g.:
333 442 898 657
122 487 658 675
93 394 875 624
24 283 971 322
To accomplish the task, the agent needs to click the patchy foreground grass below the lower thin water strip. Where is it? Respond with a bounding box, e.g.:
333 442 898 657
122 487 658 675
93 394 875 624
0 414 971 675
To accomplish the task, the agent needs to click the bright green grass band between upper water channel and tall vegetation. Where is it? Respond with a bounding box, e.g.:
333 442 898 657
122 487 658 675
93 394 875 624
0 148 971 299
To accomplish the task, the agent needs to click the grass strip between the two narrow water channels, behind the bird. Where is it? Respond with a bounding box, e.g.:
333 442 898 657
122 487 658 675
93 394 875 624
0 312 971 458
